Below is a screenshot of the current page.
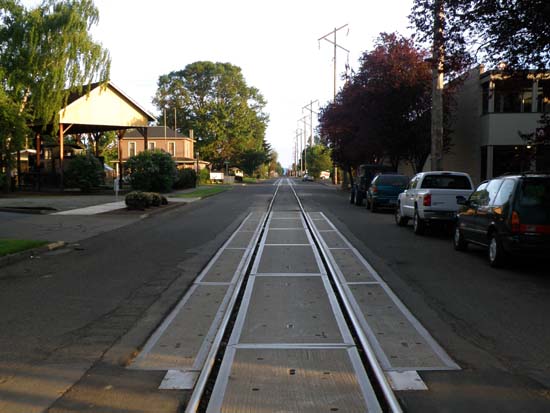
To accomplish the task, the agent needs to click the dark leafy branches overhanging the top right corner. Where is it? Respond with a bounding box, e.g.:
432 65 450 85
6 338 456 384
409 0 550 74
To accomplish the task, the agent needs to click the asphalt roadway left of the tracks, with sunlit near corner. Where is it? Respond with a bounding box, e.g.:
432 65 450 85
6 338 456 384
0 184 274 413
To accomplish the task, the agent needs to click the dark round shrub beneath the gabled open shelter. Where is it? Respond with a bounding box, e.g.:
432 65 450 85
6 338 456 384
64 153 104 192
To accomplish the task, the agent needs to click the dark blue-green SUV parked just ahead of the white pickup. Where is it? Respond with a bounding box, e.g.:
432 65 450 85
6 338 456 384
367 174 409 212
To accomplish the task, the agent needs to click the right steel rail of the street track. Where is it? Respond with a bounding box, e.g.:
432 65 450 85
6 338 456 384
290 180 403 413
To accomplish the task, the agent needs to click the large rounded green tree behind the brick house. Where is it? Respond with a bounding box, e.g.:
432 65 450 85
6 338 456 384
153 62 268 169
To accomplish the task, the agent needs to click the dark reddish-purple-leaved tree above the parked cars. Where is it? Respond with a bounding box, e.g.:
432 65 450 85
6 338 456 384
319 33 449 180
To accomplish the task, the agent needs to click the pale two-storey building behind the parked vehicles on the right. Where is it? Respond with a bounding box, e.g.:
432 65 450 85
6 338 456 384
442 66 550 182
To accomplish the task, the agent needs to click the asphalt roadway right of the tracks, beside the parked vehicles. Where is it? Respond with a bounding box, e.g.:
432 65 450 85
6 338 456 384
297 183 550 412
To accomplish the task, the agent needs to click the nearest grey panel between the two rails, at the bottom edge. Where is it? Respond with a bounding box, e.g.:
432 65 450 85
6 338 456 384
207 348 381 413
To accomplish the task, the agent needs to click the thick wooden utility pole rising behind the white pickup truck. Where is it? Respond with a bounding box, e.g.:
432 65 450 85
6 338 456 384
430 0 445 171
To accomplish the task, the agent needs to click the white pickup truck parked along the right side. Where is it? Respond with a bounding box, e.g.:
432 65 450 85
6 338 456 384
395 171 474 235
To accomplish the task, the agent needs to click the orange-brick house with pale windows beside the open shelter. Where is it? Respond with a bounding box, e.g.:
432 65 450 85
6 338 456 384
120 126 208 169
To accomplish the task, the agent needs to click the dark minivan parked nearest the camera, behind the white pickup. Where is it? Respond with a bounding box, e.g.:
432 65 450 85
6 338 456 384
453 173 550 267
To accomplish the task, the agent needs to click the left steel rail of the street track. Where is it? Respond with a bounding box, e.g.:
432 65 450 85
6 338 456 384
185 181 281 413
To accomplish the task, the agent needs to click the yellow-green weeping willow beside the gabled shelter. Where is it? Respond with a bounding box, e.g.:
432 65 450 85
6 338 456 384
0 0 110 181
